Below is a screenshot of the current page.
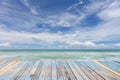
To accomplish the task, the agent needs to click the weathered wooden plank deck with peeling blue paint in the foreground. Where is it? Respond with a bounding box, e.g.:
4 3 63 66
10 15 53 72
0 59 120 80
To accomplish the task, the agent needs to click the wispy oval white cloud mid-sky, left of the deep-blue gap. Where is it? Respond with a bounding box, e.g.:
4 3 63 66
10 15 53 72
44 12 84 27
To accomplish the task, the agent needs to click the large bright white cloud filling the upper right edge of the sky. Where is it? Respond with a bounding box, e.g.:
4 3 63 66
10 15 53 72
92 1 120 41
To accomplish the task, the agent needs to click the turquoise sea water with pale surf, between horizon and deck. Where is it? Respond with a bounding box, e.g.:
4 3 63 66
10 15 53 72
0 49 120 60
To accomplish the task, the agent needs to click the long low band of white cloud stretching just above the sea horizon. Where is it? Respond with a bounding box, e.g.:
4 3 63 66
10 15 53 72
0 28 117 48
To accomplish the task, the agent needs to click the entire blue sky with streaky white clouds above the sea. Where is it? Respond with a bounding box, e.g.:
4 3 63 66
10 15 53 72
0 0 120 49
